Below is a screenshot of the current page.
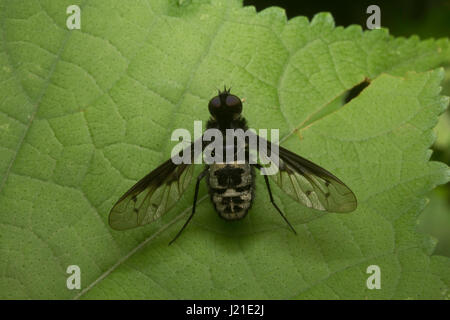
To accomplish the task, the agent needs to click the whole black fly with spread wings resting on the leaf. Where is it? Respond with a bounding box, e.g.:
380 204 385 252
109 88 357 244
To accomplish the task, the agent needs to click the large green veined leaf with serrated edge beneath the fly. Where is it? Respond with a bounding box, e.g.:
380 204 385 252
0 0 450 299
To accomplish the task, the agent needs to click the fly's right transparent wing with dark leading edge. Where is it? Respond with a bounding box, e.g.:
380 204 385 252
258 137 357 213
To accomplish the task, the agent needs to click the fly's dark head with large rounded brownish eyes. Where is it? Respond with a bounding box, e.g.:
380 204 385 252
208 88 242 123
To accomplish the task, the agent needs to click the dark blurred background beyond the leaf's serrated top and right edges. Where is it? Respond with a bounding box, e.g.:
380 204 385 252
244 0 450 257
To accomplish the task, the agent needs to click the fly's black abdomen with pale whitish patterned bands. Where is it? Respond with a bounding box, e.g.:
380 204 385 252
208 163 254 220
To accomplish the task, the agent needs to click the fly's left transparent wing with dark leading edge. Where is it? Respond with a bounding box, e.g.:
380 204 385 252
109 143 200 230
